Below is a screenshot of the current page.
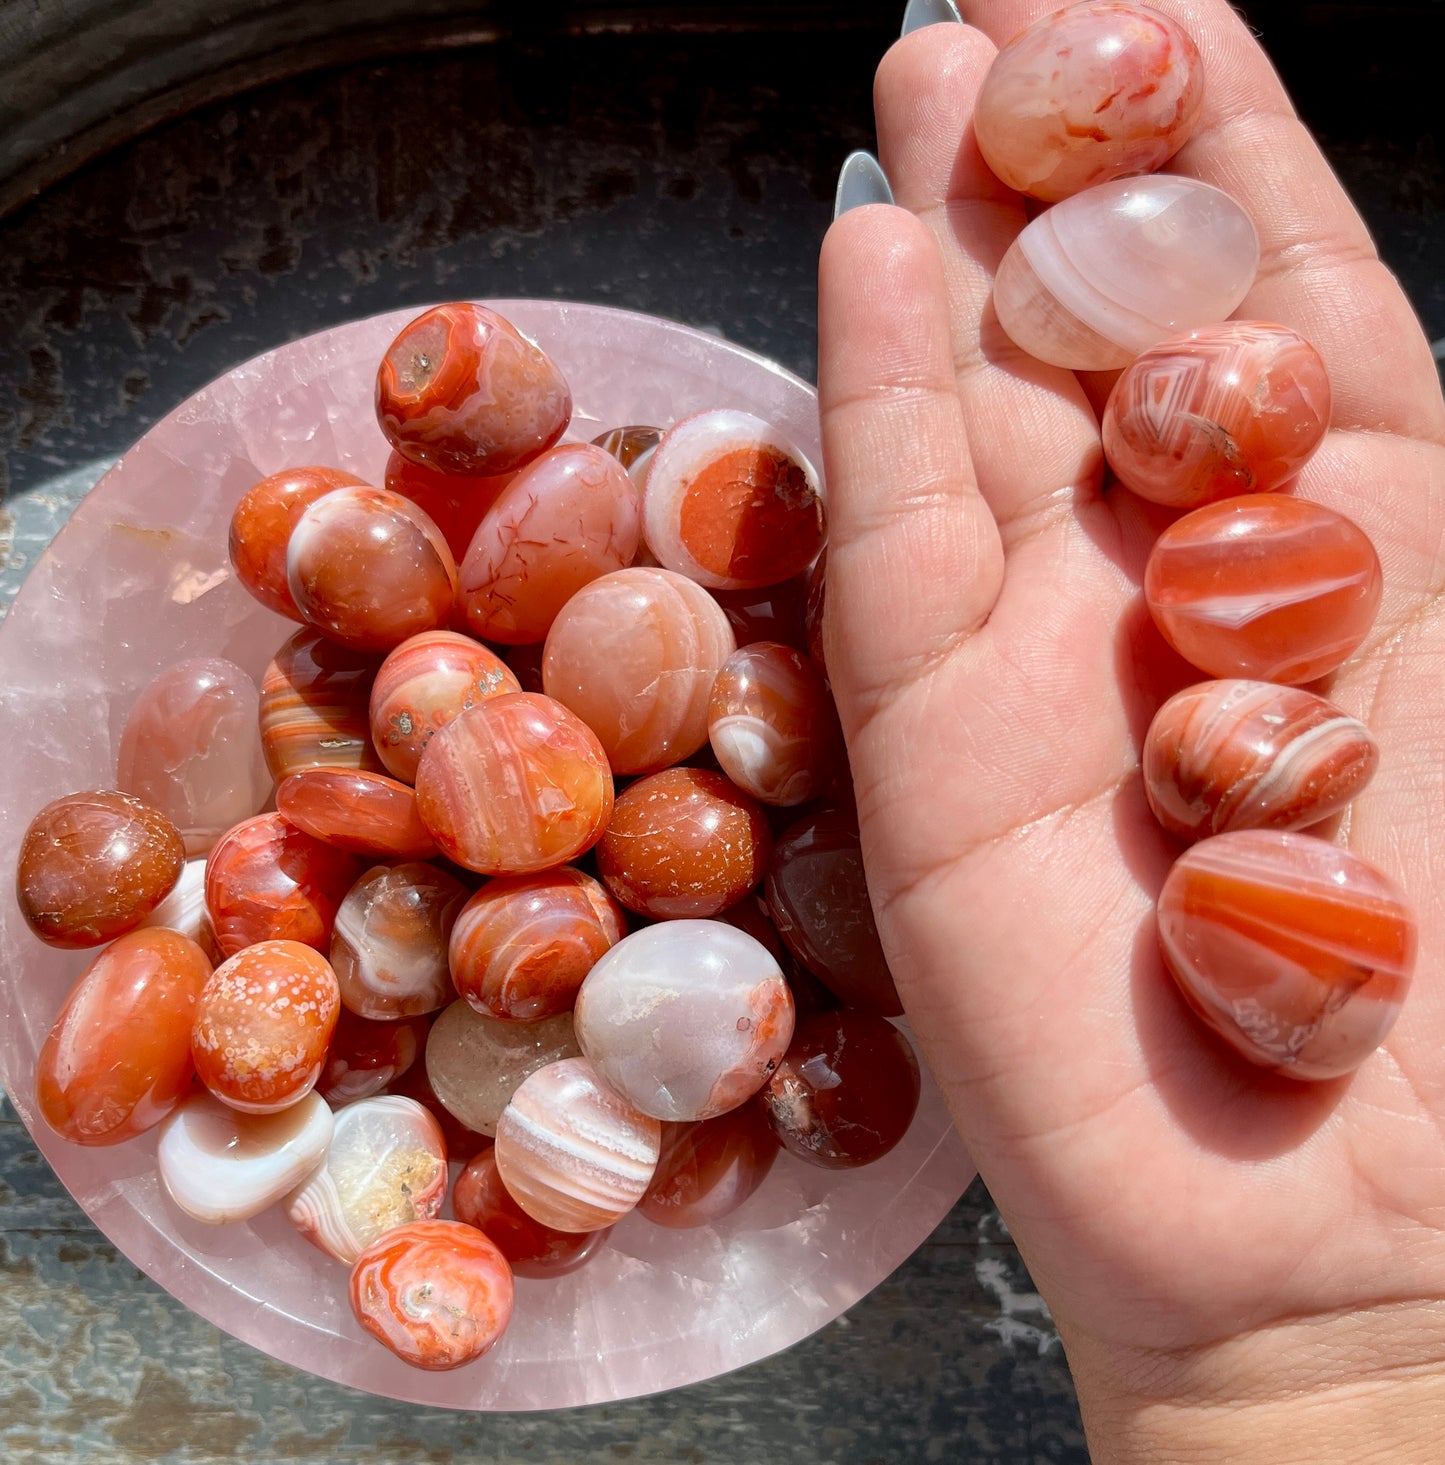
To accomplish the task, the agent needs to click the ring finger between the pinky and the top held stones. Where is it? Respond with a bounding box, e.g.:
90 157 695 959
873 25 1102 551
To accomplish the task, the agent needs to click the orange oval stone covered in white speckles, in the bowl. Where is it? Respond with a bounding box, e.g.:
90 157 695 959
191 941 341 1113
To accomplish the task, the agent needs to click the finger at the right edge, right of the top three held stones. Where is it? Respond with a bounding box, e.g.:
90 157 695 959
961 0 1445 441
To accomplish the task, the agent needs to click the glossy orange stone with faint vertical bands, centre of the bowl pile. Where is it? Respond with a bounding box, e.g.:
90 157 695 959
416 691 613 875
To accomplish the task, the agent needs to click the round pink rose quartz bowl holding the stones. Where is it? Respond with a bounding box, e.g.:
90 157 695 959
0 300 973 1409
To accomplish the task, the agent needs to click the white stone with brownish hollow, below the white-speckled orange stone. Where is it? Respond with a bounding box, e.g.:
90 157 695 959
155 1093 333 1226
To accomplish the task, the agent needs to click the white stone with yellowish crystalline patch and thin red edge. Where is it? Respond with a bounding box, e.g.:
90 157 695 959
286 1094 447 1266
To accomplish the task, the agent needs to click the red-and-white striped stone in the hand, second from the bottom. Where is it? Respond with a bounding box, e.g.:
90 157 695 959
1140 680 1379 839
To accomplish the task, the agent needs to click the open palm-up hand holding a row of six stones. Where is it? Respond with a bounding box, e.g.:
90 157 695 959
819 0 1445 1461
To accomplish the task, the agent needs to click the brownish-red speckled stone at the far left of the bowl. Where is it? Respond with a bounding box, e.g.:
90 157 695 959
15 788 186 951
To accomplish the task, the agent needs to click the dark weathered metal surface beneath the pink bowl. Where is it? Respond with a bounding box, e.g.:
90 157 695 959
0 3 1445 1465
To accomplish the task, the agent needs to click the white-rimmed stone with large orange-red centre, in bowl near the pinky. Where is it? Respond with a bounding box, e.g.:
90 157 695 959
642 409 828 590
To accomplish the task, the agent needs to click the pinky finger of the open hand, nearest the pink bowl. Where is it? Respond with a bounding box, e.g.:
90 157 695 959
818 207 1002 733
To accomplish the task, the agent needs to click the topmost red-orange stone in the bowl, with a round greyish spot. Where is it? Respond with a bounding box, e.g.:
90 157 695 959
377 302 572 476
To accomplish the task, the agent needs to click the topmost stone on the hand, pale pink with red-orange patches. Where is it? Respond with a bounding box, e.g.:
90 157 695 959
973 0 1205 204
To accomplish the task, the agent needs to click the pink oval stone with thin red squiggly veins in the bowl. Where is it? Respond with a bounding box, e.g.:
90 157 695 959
457 442 642 646
